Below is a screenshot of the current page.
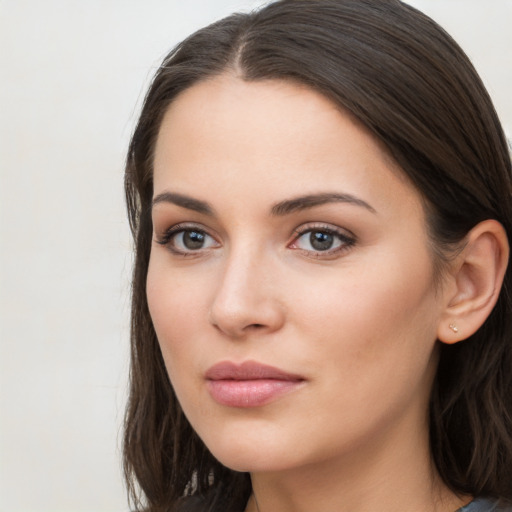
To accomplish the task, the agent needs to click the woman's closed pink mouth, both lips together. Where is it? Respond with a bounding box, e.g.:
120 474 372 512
205 361 305 408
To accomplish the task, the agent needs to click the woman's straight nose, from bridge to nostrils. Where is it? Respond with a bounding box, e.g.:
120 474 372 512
210 247 285 339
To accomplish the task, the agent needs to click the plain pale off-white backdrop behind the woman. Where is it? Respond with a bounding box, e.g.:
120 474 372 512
0 0 512 512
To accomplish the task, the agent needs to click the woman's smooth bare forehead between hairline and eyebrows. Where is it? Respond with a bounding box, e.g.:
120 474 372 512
154 74 419 217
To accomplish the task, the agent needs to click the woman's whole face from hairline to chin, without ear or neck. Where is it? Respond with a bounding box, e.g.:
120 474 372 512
147 75 448 471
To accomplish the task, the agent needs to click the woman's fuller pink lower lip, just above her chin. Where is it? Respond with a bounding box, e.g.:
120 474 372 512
207 379 303 407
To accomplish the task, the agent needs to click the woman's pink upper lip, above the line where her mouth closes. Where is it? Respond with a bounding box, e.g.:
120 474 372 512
205 361 304 381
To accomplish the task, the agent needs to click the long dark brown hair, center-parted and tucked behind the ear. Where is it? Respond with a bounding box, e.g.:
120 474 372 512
124 0 512 512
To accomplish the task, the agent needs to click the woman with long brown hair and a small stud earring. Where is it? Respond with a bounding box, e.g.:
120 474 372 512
124 0 512 512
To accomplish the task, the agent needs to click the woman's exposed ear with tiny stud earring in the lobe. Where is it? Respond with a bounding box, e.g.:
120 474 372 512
437 220 509 344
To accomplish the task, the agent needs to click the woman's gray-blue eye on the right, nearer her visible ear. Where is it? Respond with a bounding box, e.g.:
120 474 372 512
290 226 355 255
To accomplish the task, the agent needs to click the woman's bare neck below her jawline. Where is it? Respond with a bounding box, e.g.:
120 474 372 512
246 410 469 512
